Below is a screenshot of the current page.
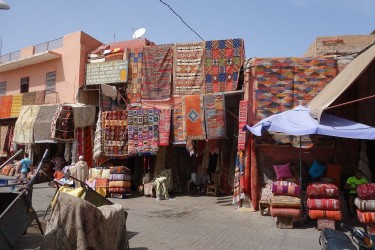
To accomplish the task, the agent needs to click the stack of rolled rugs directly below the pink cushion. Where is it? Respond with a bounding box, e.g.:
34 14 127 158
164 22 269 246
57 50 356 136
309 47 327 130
270 181 301 228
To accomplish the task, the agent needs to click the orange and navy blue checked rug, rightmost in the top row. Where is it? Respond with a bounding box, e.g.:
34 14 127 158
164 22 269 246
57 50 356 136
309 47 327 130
204 39 245 93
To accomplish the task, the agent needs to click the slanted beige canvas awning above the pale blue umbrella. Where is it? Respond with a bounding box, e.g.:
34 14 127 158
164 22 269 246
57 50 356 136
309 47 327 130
307 45 375 120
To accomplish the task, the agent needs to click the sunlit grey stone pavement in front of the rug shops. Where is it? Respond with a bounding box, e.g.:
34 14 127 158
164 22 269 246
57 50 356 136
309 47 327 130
7 184 326 250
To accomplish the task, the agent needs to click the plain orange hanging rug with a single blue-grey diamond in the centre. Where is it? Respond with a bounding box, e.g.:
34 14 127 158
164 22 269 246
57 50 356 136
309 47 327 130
182 95 206 140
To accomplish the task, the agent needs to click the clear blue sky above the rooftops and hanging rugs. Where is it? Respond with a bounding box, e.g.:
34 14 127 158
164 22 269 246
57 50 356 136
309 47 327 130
0 0 375 58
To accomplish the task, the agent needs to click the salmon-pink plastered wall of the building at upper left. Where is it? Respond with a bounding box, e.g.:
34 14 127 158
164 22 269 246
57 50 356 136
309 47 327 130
0 31 102 103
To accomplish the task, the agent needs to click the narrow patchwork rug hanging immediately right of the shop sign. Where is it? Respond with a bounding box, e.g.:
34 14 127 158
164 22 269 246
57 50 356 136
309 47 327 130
126 48 143 103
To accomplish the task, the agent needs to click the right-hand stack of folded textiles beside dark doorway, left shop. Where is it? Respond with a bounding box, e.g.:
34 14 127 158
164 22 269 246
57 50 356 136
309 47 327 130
108 166 131 199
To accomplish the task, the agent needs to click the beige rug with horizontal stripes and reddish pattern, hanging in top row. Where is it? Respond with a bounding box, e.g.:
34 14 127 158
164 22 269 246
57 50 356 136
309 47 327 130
173 42 205 96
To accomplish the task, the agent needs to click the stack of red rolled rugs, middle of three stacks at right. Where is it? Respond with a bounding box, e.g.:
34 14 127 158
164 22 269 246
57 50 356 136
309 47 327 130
307 183 342 230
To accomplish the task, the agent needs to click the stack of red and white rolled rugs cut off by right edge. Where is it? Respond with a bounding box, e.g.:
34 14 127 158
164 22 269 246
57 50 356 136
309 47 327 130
354 183 375 234
